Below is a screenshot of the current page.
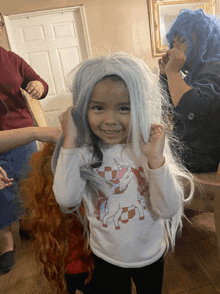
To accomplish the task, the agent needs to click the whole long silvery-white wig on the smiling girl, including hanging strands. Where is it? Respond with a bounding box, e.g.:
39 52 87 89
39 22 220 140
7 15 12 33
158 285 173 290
52 52 194 249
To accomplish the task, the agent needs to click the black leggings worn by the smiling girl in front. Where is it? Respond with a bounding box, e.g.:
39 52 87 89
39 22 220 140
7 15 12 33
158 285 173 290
74 255 164 294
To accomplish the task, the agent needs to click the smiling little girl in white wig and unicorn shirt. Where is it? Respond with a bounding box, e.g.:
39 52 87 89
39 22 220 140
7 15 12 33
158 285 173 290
52 53 193 294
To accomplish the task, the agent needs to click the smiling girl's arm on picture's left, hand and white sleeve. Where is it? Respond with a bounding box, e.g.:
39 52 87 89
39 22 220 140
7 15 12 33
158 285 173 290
53 107 86 213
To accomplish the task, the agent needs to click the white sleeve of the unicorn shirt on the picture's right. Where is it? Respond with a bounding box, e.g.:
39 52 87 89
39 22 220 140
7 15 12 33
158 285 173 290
144 161 182 219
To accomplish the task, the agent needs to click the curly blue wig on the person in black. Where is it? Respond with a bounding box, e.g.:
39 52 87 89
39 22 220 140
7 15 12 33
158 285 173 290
166 9 220 84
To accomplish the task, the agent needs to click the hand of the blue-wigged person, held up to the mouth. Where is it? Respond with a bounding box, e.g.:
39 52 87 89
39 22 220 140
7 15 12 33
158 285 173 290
164 48 186 75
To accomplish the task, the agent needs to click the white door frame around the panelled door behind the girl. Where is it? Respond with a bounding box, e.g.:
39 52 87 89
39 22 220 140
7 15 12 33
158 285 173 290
3 5 92 60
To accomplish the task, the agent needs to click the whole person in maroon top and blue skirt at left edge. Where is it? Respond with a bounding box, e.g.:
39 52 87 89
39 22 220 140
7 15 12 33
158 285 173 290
0 14 48 273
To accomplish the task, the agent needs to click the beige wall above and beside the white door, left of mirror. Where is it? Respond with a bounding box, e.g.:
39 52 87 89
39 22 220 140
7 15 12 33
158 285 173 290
0 0 157 68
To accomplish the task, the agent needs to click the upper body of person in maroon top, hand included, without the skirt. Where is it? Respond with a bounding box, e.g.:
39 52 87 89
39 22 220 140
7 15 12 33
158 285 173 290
0 15 48 130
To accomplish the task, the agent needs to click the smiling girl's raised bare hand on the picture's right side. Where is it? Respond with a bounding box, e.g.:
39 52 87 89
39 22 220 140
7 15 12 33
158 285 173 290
142 124 166 169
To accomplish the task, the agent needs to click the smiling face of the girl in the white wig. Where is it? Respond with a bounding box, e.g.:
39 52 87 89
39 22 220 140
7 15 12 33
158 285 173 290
88 78 130 145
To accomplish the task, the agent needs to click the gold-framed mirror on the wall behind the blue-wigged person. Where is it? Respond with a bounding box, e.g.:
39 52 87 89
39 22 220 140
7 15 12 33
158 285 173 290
148 0 216 57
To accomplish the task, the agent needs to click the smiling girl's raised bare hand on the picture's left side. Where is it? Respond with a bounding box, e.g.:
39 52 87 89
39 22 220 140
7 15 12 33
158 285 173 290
59 106 77 139
